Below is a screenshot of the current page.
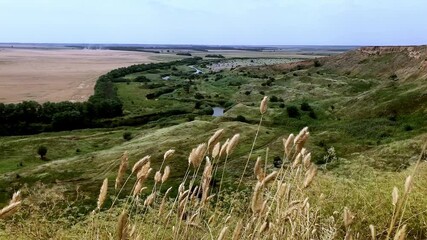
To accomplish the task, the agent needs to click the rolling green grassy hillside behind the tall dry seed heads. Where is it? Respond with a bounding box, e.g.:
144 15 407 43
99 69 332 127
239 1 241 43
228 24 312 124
0 47 427 239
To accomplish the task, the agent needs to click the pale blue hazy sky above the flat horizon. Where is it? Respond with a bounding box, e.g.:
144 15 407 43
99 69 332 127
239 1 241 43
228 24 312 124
0 0 427 45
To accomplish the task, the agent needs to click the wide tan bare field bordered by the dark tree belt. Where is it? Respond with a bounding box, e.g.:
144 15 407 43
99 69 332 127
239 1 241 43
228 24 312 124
0 48 160 103
